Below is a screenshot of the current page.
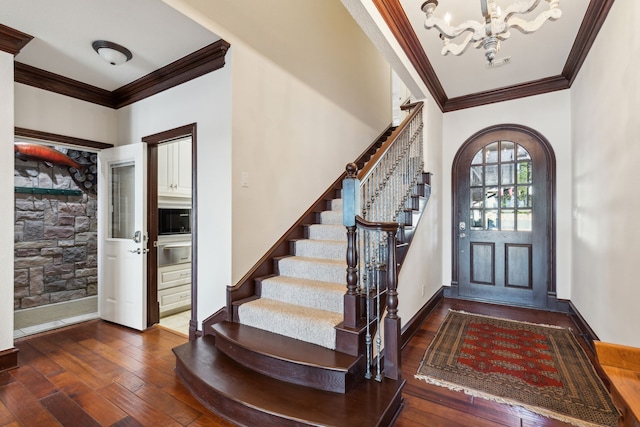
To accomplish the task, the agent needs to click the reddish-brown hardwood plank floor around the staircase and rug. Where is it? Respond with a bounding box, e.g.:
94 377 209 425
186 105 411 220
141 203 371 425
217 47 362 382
0 299 608 427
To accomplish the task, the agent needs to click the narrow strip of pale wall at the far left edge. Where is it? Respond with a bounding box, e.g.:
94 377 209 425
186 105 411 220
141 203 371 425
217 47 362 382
0 51 14 351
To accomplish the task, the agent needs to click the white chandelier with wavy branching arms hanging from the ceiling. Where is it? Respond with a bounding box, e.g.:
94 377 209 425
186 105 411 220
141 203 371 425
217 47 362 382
422 0 562 65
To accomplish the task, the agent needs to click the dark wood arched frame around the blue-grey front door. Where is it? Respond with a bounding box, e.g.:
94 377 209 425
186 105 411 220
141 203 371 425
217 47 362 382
446 124 558 310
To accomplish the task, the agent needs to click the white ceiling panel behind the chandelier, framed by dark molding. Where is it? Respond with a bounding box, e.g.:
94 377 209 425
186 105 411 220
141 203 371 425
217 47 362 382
400 0 589 98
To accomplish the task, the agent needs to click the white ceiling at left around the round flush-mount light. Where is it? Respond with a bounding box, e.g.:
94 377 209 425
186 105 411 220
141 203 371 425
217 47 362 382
0 0 220 91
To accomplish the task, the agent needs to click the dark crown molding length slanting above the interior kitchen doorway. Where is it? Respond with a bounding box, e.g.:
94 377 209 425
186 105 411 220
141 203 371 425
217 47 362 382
113 40 230 108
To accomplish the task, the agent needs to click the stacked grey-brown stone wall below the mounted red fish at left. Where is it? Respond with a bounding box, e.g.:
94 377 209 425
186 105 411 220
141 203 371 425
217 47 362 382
14 159 98 310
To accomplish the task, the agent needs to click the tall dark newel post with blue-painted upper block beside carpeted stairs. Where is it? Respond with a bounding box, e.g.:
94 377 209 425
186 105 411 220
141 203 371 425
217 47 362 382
342 163 361 328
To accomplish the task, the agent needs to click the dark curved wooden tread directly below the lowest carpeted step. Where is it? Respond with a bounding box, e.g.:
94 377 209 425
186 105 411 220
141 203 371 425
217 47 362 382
212 322 357 371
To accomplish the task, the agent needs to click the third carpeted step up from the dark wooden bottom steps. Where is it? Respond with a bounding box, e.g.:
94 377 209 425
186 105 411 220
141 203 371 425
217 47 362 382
276 256 347 284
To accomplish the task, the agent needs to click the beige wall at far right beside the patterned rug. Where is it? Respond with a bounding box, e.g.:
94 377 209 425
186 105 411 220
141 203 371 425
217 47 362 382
571 0 640 347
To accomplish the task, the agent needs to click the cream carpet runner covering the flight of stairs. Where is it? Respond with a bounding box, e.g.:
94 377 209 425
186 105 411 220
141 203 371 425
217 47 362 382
238 199 347 350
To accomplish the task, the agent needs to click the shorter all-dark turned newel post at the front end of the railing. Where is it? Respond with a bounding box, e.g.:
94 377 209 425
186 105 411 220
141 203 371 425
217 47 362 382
384 231 402 380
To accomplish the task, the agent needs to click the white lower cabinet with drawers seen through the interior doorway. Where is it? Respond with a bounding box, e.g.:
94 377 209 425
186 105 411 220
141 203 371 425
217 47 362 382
158 263 191 317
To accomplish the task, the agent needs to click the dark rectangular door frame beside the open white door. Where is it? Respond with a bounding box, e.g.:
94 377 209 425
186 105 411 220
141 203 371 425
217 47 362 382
142 123 198 340
